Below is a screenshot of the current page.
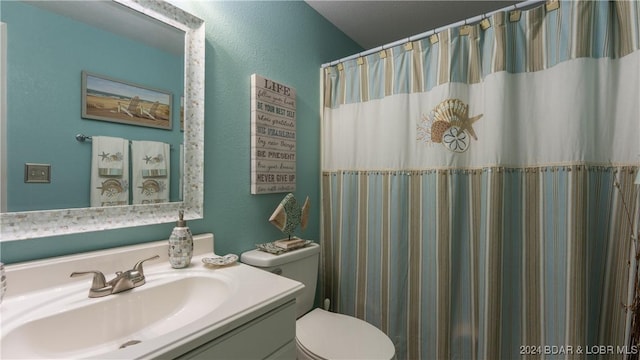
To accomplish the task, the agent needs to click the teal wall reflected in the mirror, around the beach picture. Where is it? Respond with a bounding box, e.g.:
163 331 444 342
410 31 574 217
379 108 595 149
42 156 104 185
0 1 184 211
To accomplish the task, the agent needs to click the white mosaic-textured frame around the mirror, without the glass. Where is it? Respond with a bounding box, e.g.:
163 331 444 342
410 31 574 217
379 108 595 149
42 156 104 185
0 0 205 241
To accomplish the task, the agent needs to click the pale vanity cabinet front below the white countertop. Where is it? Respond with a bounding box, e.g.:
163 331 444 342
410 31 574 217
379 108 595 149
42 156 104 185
178 300 296 360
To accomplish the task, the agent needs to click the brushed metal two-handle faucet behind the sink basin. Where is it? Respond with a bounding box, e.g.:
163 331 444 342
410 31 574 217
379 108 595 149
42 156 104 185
71 255 160 298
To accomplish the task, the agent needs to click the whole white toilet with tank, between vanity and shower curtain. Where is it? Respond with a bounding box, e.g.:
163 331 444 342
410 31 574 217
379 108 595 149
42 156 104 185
240 243 395 360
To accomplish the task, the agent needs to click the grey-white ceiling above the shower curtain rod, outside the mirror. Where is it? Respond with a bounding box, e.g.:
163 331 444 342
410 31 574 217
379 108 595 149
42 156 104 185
305 0 520 50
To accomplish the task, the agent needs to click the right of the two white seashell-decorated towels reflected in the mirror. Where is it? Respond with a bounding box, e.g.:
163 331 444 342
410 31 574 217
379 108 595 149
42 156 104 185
131 141 170 204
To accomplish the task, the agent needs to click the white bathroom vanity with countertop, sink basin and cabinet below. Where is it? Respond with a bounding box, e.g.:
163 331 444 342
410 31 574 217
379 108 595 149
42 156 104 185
0 234 304 359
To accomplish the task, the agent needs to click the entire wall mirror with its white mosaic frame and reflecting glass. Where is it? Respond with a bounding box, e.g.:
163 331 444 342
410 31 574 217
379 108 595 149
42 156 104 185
0 0 204 241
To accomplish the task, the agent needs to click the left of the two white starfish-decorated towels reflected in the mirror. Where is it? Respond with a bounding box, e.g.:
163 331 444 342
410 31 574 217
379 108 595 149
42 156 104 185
90 136 129 207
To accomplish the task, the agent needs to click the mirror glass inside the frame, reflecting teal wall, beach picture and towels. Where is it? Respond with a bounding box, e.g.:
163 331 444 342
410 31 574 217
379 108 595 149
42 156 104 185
0 1 184 212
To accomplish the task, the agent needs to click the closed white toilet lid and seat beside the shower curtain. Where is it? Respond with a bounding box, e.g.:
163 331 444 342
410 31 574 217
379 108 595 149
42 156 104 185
296 309 395 360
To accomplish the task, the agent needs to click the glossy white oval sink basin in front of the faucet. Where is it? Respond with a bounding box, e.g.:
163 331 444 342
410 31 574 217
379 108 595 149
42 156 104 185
1 271 233 359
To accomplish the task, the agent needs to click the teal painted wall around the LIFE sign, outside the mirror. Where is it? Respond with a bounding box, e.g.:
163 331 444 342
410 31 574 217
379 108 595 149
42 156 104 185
0 1 362 263
